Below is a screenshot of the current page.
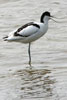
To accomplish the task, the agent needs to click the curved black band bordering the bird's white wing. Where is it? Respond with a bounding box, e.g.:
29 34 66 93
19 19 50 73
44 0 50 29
14 22 40 37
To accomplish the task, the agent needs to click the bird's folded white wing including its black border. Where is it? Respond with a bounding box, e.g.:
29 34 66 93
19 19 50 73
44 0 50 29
14 22 40 37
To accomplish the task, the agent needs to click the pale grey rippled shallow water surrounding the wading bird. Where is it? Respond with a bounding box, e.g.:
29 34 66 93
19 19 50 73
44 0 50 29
0 0 67 100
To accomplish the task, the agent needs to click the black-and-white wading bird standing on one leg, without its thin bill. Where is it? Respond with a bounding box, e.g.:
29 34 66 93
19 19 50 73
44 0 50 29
4 11 52 66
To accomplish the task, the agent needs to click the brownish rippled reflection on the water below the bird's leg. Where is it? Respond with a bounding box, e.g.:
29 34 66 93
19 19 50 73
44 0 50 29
17 69 55 98
